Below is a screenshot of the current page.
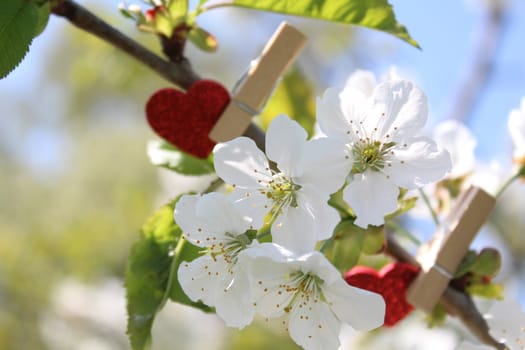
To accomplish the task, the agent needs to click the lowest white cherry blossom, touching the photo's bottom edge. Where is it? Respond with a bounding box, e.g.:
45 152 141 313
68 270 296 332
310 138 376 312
239 243 385 350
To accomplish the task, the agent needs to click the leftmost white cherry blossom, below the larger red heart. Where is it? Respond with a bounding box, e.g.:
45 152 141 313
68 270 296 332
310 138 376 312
175 193 255 328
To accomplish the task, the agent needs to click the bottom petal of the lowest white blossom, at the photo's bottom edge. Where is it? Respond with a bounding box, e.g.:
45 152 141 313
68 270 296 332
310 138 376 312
288 300 341 350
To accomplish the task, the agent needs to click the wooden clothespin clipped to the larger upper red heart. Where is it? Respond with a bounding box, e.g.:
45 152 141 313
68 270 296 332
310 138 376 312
209 22 307 142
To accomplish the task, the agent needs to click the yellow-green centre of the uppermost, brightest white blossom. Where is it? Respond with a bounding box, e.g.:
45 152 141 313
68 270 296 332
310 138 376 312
352 140 395 174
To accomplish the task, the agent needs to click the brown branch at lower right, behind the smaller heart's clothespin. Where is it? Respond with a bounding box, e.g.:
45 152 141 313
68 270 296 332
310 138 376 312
386 232 508 350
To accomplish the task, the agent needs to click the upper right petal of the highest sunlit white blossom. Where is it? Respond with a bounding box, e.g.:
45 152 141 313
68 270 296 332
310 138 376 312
366 80 428 141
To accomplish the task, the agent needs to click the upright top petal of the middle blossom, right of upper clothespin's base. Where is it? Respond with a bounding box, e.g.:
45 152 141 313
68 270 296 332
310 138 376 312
266 115 308 176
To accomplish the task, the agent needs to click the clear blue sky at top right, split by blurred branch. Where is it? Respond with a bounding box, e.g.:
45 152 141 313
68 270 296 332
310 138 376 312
391 0 525 160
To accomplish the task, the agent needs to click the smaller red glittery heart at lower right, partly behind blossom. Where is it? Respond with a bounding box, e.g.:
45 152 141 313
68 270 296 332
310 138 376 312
345 262 419 327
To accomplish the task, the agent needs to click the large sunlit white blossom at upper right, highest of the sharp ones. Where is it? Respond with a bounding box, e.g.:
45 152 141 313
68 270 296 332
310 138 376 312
317 80 451 228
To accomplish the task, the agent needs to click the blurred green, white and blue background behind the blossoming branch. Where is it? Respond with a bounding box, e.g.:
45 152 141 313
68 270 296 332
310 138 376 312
0 0 525 350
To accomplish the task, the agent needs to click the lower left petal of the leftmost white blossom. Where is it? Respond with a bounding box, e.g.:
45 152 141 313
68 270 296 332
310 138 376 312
177 255 229 306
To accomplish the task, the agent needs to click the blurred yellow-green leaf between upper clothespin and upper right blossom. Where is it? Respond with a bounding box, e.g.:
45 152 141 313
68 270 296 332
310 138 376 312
260 67 315 136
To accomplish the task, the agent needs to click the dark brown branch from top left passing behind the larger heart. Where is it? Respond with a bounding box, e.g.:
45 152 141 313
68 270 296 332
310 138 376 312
51 0 265 150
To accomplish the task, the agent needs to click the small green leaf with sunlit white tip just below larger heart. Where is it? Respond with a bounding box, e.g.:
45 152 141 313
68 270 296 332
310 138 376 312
148 141 215 176
